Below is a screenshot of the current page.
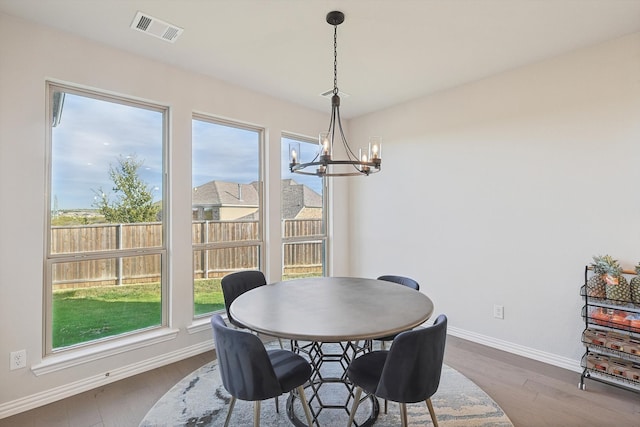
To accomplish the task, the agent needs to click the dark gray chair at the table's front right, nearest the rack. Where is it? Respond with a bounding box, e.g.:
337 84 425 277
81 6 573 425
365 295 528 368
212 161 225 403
347 314 447 427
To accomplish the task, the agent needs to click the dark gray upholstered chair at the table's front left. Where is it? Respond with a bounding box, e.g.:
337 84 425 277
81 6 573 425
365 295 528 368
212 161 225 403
211 314 312 427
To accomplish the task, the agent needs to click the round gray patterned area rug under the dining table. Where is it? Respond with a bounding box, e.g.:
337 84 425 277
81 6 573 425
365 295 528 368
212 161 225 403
140 344 513 427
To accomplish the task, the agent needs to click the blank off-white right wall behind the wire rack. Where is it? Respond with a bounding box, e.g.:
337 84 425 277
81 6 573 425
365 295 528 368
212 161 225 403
350 34 640 368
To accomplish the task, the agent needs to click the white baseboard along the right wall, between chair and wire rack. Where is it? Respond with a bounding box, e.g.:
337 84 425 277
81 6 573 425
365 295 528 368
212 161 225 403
447 326 582 372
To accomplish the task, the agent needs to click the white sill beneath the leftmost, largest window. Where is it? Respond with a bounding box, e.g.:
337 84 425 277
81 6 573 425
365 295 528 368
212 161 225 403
31 328 180 376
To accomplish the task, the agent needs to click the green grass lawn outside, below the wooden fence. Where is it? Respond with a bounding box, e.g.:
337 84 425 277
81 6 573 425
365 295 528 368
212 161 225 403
53 279 224 348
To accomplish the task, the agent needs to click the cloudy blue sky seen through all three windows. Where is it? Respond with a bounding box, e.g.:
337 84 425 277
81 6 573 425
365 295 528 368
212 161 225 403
51 93 322 209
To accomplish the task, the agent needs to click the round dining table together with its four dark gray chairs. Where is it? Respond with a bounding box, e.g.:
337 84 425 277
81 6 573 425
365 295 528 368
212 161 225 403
211 270 447 427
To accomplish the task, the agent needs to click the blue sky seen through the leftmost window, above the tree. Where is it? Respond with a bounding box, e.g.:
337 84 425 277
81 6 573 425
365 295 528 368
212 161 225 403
51 94 162 209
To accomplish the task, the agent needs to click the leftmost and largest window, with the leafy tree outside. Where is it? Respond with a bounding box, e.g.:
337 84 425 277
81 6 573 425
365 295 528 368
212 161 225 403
45 83 167 353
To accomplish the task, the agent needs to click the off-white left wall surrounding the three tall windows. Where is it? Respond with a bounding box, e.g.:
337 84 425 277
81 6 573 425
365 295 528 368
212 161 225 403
0 14 347 418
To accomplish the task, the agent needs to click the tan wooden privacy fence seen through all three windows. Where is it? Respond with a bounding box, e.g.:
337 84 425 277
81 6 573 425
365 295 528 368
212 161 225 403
51 219 324 289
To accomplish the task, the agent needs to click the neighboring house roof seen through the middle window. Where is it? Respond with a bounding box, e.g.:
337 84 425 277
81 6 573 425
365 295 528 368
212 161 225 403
191 181 259 207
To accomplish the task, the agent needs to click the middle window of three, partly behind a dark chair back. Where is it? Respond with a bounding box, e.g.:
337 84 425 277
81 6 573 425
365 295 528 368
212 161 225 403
191 116 263 317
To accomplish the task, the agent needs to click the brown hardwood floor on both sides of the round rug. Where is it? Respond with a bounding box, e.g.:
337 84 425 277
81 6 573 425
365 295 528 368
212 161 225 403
0 336 640 427
